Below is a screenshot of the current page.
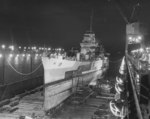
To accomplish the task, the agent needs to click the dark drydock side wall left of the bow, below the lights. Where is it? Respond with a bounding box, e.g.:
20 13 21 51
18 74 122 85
0 54 43 100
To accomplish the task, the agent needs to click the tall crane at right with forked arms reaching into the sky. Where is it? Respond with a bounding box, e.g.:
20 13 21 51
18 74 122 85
109 0 143 119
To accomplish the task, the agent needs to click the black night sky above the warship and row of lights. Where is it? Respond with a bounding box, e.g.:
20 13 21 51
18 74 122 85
0 0 150 54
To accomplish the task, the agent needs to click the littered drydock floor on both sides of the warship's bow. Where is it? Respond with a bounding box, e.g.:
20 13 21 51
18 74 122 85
0 78 116 119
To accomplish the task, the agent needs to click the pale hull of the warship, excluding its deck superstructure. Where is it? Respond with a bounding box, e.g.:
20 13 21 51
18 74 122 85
42 58 108 111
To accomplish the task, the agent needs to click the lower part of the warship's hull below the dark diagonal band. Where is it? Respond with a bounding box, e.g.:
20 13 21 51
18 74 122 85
44 70 102 111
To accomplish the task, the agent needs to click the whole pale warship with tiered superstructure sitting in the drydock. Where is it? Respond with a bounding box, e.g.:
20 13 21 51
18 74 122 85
42 31 109 111
